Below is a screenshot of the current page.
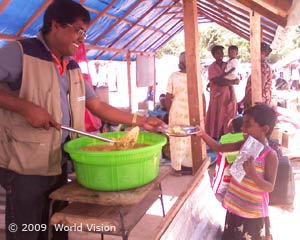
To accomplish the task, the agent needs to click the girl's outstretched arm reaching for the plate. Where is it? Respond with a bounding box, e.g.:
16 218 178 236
197 130 244 152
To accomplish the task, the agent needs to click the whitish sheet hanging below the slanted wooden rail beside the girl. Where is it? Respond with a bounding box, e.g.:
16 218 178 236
159 169 226 240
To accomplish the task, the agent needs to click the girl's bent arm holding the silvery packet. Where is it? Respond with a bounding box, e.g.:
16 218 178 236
243 151 278 192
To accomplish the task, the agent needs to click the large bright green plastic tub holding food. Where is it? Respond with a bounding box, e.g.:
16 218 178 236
64 132 167 191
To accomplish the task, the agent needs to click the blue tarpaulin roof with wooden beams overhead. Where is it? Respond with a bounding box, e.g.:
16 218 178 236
0 0 292 60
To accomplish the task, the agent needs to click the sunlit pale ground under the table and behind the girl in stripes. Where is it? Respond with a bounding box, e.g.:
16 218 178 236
0 158 300 240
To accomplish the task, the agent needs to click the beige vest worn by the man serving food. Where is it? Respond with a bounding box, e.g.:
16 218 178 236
0 39 85 176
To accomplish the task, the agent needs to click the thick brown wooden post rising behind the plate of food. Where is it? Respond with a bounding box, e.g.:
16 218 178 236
183 0 206 174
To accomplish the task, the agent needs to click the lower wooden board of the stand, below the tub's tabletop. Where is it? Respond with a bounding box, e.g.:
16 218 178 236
50 188 161 235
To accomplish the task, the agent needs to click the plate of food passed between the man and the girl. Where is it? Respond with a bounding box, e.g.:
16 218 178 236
160 125 200 137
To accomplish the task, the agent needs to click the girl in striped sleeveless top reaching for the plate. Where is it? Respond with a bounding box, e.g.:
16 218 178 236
198 103 278 240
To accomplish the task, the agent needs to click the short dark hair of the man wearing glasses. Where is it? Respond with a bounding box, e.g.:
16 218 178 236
41 0 91 34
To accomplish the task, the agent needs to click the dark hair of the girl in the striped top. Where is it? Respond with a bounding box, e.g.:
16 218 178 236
244 103 277 138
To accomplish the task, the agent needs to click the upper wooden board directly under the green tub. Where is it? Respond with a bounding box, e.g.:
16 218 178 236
50 166 171 206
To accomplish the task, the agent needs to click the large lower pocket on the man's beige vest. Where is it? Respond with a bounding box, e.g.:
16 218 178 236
7 127 51 175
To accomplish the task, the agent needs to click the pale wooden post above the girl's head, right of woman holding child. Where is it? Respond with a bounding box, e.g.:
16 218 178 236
250 11 262 104
